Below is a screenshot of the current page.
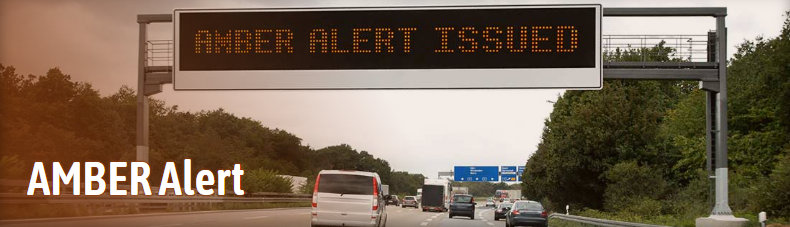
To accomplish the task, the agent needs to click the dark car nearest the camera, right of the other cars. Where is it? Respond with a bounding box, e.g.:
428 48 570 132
505 200 549 227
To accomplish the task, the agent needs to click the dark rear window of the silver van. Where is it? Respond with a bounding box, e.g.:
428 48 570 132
318 174 373 195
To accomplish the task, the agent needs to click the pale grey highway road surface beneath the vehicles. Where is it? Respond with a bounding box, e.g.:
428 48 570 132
0 206 505 227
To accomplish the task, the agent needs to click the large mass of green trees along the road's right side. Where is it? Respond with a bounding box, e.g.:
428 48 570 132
523 12 790 226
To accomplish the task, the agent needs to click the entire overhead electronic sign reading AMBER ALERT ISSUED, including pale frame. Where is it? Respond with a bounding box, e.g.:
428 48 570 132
173 5 602 90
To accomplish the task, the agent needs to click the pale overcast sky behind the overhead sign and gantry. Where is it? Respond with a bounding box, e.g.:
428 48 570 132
0 0 790 177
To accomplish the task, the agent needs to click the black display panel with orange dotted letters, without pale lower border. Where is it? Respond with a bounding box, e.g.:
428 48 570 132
178 7 598 70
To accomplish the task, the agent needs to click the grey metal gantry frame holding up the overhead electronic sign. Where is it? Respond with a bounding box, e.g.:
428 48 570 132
137 7 732 216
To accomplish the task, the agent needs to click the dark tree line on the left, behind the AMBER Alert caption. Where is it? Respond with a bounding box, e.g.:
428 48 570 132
0 64 424 194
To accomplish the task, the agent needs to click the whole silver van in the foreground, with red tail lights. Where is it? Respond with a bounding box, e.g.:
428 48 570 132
310 170 387 227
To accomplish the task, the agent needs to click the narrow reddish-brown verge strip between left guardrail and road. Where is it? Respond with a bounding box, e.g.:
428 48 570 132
0 202 310 220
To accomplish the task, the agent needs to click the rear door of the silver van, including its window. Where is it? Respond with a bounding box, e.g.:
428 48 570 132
317 174 381 225
